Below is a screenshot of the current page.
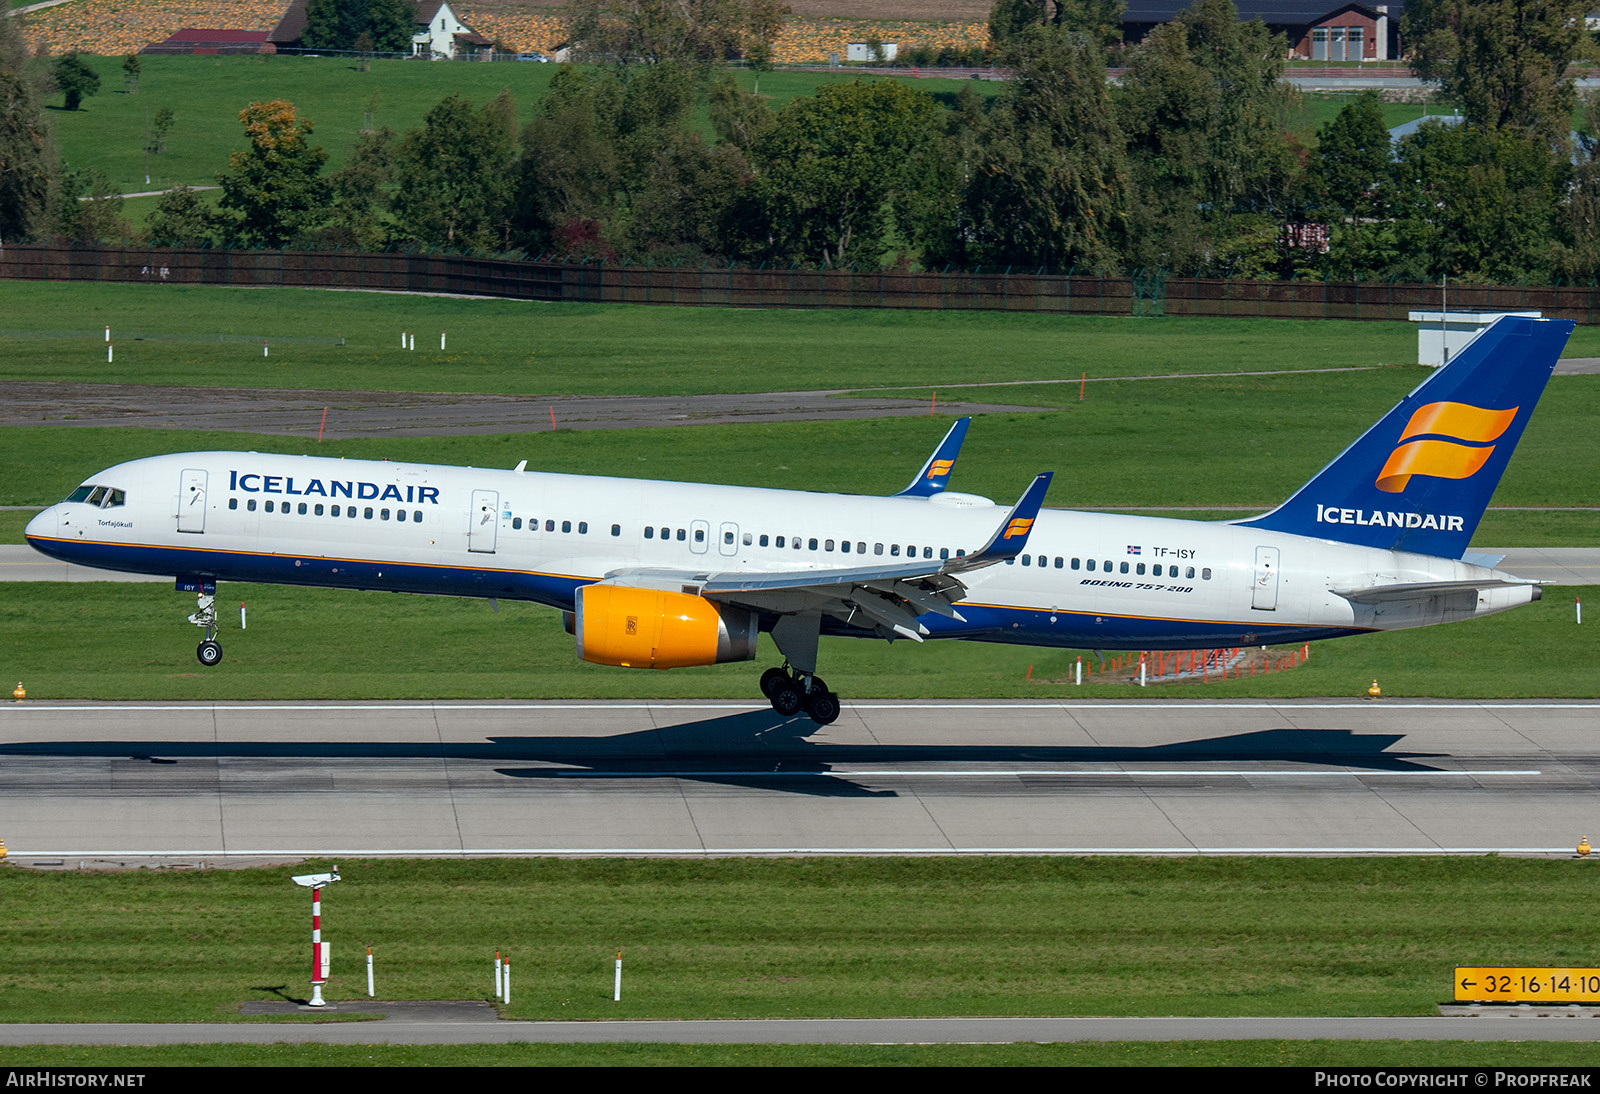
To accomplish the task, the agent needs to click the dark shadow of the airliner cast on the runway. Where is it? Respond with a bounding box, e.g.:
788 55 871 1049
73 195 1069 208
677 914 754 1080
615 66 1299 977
0 712 1448 797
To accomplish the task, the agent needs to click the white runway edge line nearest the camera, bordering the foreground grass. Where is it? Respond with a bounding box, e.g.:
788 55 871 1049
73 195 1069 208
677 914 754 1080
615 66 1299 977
10 846 1573 864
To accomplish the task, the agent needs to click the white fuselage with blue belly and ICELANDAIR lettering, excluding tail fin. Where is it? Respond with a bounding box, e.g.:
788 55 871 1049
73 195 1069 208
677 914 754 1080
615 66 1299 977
18 451 1536 649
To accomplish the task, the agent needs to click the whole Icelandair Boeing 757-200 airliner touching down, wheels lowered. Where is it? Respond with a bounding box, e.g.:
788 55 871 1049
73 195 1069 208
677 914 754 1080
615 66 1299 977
27 317 1573 725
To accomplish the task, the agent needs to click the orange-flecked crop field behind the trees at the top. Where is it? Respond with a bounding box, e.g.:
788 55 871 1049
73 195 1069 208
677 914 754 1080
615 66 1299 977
15 0 989 64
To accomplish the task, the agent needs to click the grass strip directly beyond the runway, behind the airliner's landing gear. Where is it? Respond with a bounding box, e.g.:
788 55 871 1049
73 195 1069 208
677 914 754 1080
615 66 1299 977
0 582 1600 703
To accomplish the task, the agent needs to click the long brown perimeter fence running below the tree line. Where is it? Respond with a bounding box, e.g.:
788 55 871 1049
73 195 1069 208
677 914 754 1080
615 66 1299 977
0 243 1600 323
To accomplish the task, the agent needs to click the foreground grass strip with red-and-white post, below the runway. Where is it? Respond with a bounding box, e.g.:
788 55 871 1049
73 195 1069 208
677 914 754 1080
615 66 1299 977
0 857 1595 1022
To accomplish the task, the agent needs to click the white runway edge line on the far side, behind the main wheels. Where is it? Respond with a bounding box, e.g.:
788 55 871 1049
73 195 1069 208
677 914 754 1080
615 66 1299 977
9 699 1600 713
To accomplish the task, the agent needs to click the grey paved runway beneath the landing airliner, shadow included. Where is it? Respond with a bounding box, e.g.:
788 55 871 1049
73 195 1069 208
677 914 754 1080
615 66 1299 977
0 701 1600 868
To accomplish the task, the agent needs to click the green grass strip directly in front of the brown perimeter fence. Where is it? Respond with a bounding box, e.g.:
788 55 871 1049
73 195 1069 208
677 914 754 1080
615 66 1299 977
0 281 1440 398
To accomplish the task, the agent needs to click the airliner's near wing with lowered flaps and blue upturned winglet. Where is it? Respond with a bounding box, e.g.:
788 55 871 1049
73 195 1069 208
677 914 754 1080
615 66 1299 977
606 473 1050 641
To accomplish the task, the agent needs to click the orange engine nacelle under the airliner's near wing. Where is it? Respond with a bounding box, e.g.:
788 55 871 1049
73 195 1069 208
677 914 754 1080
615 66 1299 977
571 585 758 669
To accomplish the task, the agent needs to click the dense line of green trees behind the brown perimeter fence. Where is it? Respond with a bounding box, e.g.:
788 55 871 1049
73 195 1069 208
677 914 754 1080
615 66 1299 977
9 0 1600 281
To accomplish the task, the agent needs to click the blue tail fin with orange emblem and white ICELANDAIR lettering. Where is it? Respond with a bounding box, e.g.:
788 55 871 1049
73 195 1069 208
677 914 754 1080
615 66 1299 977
1237 317 1573 558
